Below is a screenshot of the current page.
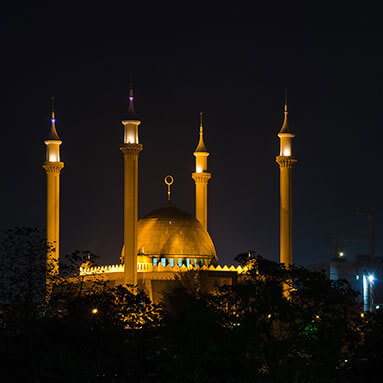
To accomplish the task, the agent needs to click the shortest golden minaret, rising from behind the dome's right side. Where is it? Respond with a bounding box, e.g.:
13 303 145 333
192 112 211 230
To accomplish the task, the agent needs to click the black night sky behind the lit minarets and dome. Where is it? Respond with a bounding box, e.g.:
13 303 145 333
0 2 383 265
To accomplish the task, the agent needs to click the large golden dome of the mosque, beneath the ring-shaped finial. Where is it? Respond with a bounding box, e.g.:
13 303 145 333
137 204 215 260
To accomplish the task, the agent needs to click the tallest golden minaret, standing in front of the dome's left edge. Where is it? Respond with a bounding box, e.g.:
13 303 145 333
120 79 142 286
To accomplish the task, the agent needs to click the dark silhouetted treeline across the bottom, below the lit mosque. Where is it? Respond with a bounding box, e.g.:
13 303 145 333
0 229 383 383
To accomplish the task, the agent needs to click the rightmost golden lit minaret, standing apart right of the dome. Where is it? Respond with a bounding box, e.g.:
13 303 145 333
276 92 297 265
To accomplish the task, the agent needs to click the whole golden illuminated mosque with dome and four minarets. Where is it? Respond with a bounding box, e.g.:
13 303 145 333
43 87 296 302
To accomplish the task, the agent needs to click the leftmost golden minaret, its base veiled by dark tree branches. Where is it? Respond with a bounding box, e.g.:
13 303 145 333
43 97 64 275
